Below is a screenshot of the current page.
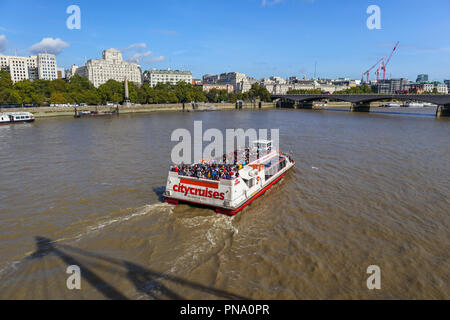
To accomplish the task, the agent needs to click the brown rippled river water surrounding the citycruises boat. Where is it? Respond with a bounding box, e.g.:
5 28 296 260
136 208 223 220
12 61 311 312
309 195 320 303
0 109 450 299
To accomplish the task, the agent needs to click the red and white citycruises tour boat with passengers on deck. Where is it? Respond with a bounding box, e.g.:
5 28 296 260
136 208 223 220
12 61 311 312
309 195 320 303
164 140 295 216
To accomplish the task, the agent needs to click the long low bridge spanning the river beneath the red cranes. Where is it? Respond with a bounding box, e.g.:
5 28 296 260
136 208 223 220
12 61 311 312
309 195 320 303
271 94 450 117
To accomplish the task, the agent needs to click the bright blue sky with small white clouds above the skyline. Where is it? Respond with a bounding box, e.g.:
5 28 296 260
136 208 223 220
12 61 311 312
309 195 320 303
0 0 450 81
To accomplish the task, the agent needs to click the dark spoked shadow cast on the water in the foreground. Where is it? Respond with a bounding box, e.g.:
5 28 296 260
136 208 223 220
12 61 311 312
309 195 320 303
27 236 247 300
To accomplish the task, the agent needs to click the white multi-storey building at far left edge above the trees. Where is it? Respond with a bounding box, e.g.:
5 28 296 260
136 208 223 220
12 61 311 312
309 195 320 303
0 53 57 83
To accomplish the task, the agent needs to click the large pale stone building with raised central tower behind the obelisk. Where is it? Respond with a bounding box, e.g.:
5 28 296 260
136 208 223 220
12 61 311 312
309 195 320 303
75 49 142 87
